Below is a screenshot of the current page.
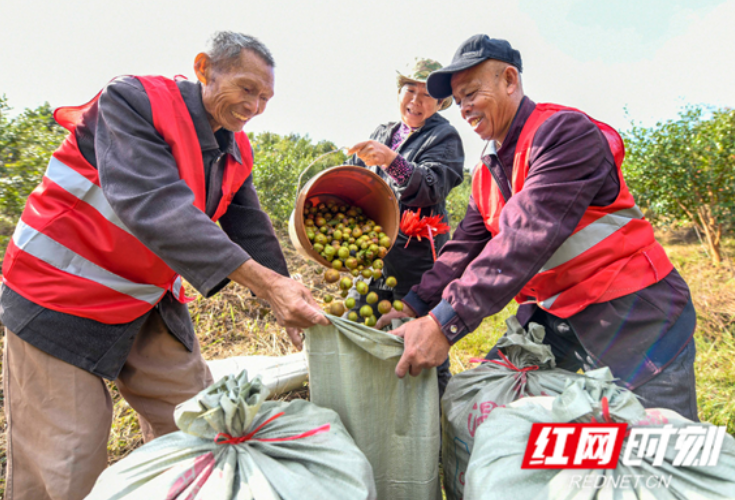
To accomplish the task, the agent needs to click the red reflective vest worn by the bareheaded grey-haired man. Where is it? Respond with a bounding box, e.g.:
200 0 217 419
3 76 253 324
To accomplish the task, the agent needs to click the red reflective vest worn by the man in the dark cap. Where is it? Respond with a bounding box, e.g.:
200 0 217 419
472 104 674 318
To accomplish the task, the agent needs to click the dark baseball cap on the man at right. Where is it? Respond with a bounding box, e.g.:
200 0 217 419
426 35 523 99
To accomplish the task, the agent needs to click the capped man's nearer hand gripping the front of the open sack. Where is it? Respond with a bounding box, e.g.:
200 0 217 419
391 316 450 378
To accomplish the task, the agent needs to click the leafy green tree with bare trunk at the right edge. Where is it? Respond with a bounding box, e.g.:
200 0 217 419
624 107 735 264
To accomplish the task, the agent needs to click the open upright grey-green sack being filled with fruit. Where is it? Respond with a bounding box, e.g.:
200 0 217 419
305 315 441 500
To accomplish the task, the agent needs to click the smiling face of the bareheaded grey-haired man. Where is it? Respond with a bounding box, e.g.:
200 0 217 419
194 50 274 132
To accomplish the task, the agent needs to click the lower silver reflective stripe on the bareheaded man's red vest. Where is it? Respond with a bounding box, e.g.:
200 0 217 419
13 221 166 305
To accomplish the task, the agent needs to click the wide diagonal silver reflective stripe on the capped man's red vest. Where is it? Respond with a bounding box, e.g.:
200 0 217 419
539 205 643 273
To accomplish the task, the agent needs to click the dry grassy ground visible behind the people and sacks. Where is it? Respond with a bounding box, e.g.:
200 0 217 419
0 233 735 499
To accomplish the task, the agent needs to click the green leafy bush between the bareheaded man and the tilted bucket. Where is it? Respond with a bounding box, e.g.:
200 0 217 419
250 132 347 227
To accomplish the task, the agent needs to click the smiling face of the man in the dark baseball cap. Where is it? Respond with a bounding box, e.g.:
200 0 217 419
452 59 523 143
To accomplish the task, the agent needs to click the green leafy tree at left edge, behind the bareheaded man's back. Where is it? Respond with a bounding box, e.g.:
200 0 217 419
0 95 67 256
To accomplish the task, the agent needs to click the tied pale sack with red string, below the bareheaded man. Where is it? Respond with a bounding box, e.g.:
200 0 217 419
87 371 376 500
